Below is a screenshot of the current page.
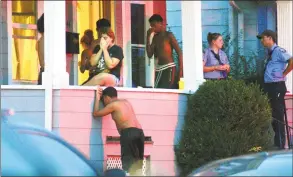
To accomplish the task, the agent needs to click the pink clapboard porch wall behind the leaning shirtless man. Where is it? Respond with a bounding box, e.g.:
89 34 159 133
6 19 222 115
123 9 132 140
53 90 187 175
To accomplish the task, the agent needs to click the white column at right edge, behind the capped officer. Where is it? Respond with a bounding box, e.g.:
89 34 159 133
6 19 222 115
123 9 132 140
277 1 293 94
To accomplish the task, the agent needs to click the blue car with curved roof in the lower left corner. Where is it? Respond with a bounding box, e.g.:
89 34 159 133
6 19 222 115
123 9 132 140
1 110 124 176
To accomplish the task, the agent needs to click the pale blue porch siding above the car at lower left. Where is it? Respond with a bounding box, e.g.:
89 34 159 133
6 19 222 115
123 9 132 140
1 89 45 127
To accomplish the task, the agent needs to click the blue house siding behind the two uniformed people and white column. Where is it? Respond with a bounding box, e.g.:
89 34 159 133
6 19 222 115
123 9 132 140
166 1 276 57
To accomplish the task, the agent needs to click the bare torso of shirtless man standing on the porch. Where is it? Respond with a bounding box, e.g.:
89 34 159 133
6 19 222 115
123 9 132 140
153 31 174 65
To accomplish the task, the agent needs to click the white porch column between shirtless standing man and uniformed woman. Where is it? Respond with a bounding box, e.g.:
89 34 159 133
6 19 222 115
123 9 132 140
181 1 205 91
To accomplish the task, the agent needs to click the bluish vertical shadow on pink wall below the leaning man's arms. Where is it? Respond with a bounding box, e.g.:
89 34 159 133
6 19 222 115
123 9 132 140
89 91 104 175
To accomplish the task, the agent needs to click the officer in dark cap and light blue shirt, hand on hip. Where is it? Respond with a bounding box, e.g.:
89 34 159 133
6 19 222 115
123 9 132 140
257 30 293 149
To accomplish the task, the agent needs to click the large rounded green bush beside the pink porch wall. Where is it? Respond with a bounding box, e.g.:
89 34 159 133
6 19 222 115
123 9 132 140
175 80 273 176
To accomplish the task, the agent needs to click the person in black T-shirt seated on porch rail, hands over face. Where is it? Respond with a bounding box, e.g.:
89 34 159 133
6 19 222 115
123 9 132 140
84 28 124 86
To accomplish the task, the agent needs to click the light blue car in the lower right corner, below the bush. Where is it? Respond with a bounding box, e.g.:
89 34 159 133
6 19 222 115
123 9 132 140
189 150 293 176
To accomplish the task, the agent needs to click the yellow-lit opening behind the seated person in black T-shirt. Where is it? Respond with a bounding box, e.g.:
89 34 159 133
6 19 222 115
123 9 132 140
77 1 115 85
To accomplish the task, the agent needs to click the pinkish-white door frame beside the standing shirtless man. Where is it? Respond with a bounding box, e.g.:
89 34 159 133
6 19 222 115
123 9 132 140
122 1 155 87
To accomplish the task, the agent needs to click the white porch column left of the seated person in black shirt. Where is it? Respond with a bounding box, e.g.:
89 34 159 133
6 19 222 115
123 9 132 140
43 1 69 87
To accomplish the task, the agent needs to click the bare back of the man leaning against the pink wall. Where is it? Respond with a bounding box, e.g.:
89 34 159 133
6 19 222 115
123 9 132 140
109 99 141 133
